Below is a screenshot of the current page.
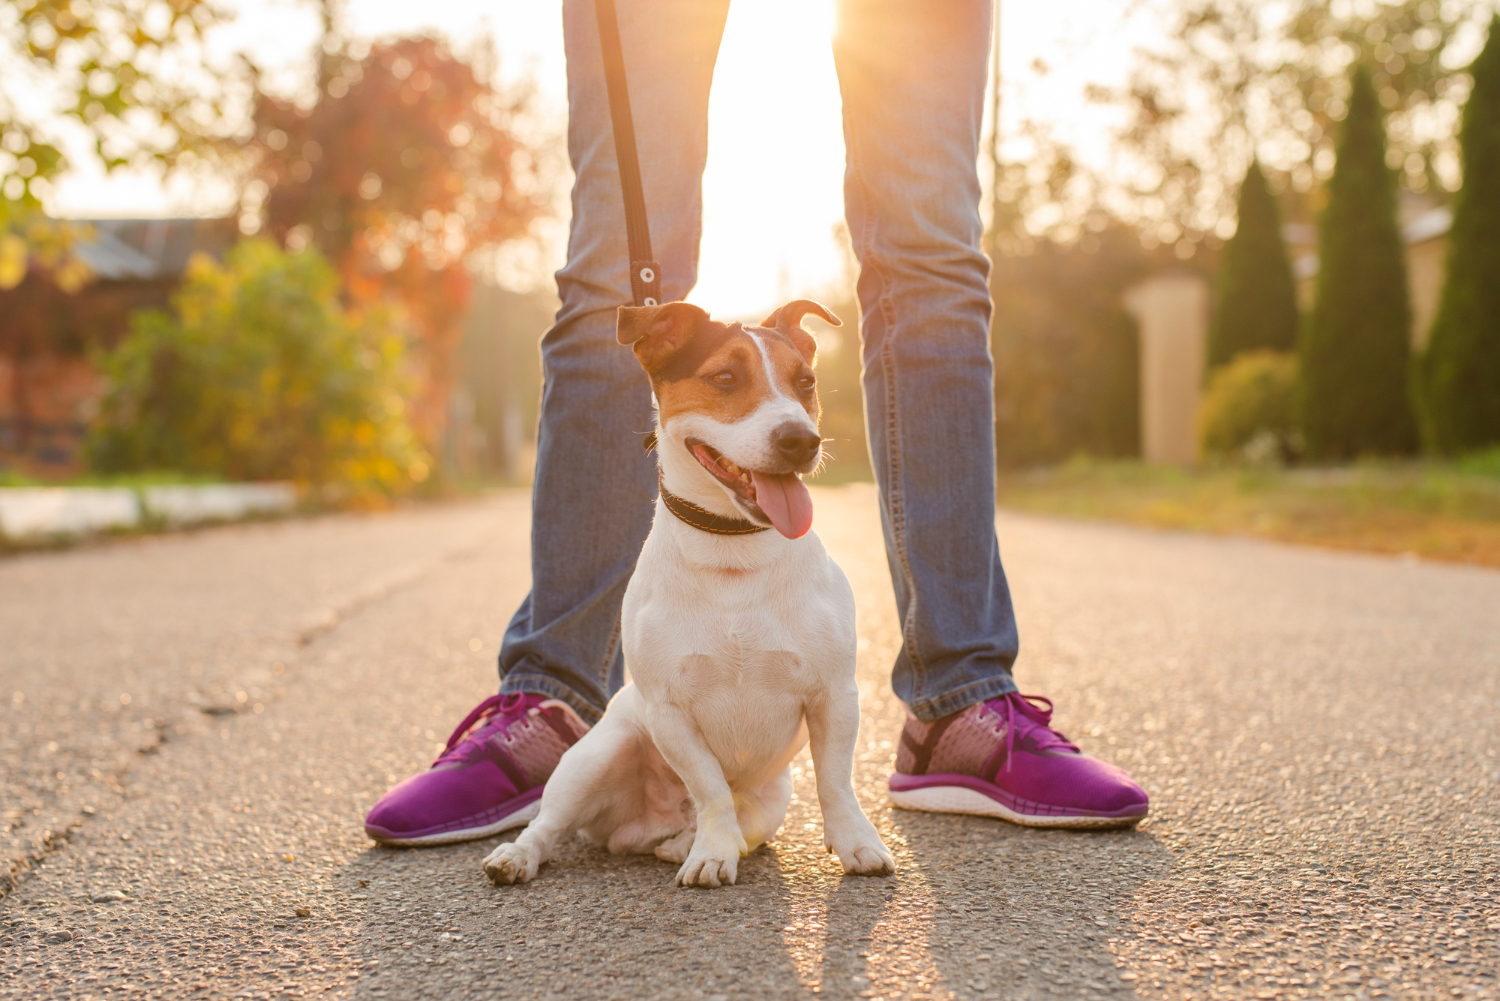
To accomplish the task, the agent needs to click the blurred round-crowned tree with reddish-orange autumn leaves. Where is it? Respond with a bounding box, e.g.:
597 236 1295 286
254 35 542 443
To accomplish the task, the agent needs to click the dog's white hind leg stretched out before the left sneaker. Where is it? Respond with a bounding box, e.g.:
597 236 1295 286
485 713 644 885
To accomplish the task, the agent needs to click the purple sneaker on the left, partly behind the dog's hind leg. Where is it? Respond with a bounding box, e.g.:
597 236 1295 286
365 695 588 845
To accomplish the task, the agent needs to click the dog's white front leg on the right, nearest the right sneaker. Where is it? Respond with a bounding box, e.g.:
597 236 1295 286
807 690 896 876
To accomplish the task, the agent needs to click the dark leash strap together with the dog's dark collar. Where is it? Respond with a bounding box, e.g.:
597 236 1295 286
594 0 767 536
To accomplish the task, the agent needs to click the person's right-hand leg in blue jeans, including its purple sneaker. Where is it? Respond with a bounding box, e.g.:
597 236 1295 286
834 0 1148 827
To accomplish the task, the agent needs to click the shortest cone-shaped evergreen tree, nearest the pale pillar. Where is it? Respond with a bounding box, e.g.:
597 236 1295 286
1209 161 1298 369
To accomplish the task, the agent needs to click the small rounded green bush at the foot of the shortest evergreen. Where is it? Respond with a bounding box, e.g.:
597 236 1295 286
1199 351 1302 461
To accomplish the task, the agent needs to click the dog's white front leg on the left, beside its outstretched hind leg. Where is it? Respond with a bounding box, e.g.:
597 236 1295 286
648 705 746 887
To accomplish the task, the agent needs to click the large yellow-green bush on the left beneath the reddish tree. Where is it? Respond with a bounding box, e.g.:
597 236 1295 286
89 240 428 495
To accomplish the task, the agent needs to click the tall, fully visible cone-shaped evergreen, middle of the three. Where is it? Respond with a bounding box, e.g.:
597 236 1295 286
1299 66 1416 459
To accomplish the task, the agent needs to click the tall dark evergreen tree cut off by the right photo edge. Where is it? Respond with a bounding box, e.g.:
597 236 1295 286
1418 15 1500 453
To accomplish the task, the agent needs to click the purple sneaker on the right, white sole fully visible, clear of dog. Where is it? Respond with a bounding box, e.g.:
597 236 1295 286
890 692 1151 827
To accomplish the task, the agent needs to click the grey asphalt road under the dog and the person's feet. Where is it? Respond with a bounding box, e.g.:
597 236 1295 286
0 488 1500 999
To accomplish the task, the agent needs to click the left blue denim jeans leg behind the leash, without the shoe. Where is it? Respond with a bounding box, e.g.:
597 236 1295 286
500 0 729 722
